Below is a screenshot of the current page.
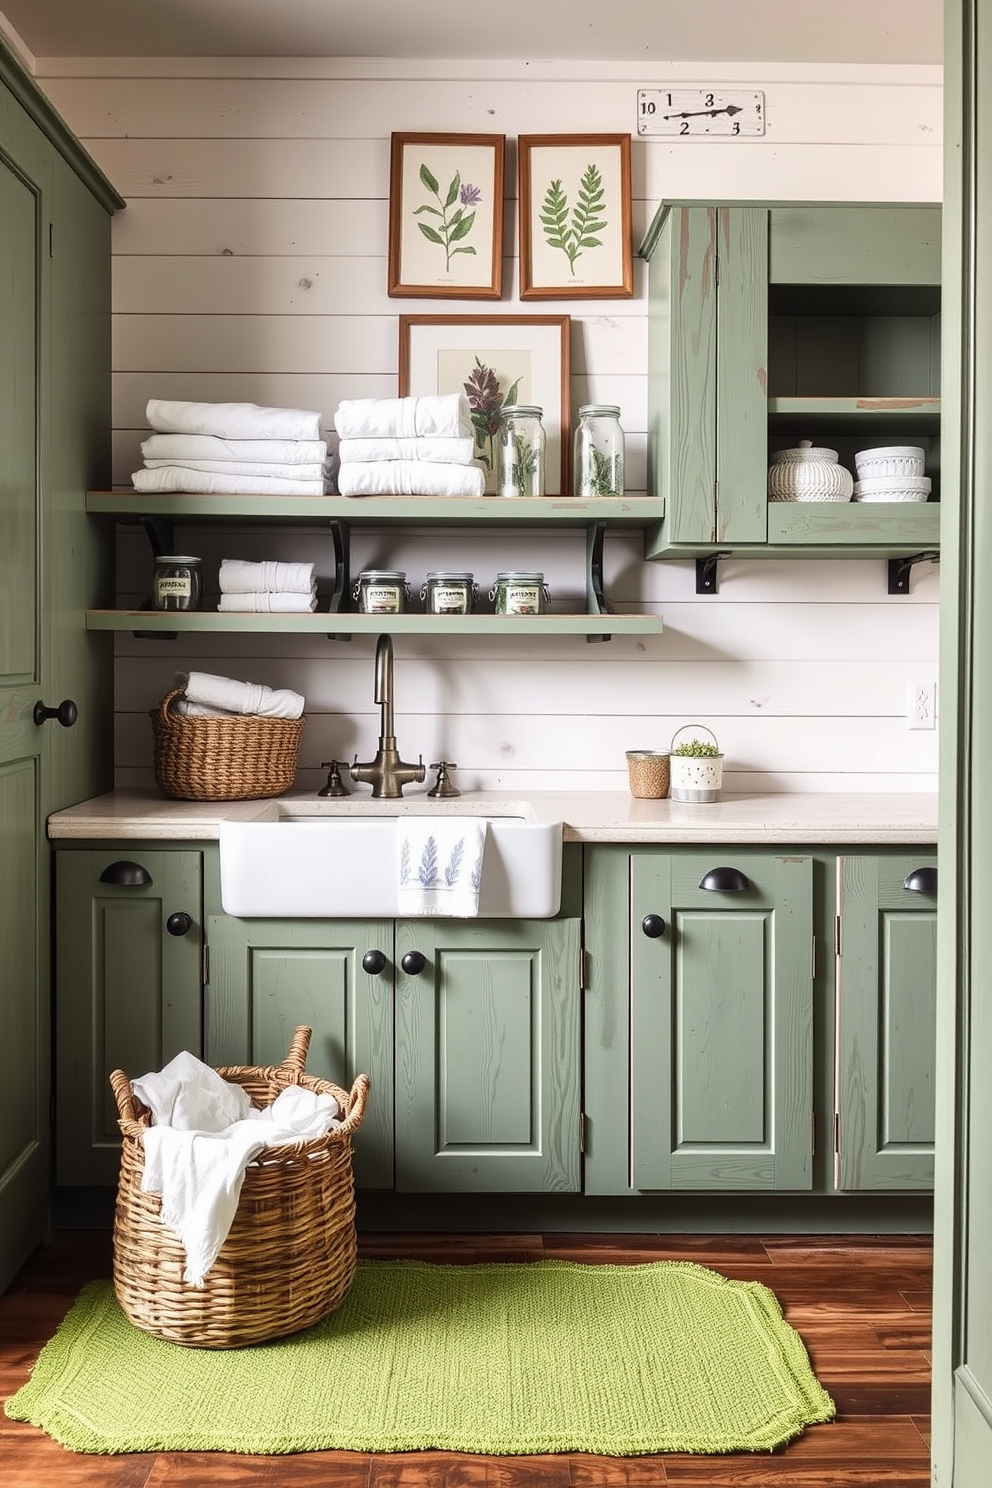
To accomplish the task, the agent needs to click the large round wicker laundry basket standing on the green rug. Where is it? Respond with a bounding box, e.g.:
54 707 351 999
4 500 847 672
110 1028 369 1348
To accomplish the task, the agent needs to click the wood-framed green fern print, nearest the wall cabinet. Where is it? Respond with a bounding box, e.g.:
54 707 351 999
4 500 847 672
518 134 634 299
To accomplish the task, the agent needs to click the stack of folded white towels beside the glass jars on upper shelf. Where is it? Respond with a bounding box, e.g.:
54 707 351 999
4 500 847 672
335 393 486 496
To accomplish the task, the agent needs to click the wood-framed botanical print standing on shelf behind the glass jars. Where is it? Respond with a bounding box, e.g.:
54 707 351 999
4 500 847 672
399 315 571 496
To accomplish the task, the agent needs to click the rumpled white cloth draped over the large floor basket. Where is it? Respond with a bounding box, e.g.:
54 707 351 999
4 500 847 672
131 1052 341 1287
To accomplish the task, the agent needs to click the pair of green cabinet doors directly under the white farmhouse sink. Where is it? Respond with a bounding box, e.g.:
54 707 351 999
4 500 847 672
205 915 580 1192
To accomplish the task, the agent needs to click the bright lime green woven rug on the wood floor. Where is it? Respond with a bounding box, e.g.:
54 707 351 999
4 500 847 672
6 1260 834 1457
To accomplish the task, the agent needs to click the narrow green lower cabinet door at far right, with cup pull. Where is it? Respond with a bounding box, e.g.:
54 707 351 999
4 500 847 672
836 857 937 1189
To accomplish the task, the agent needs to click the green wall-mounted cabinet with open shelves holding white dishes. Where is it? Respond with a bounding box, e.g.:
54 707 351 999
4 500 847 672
641 202 940 558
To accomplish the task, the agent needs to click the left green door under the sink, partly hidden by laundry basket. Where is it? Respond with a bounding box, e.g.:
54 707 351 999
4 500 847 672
205 915 394 1189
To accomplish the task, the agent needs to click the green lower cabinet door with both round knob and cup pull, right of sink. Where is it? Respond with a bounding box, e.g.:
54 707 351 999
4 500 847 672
629 851 812 1190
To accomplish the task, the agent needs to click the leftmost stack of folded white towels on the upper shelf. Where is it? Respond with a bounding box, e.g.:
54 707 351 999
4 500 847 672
131 397 330 496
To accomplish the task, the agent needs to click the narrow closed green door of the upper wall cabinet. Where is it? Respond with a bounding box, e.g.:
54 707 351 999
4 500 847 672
715 207 769 543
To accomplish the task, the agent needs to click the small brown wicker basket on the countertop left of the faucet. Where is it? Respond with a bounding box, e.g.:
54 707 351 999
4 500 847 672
149 687 306 801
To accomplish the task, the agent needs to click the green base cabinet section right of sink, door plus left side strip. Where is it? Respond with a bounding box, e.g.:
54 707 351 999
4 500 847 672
586 848 814 1193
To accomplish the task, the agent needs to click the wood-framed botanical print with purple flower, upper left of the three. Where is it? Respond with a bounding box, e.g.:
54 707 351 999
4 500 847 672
387 134 506 299
